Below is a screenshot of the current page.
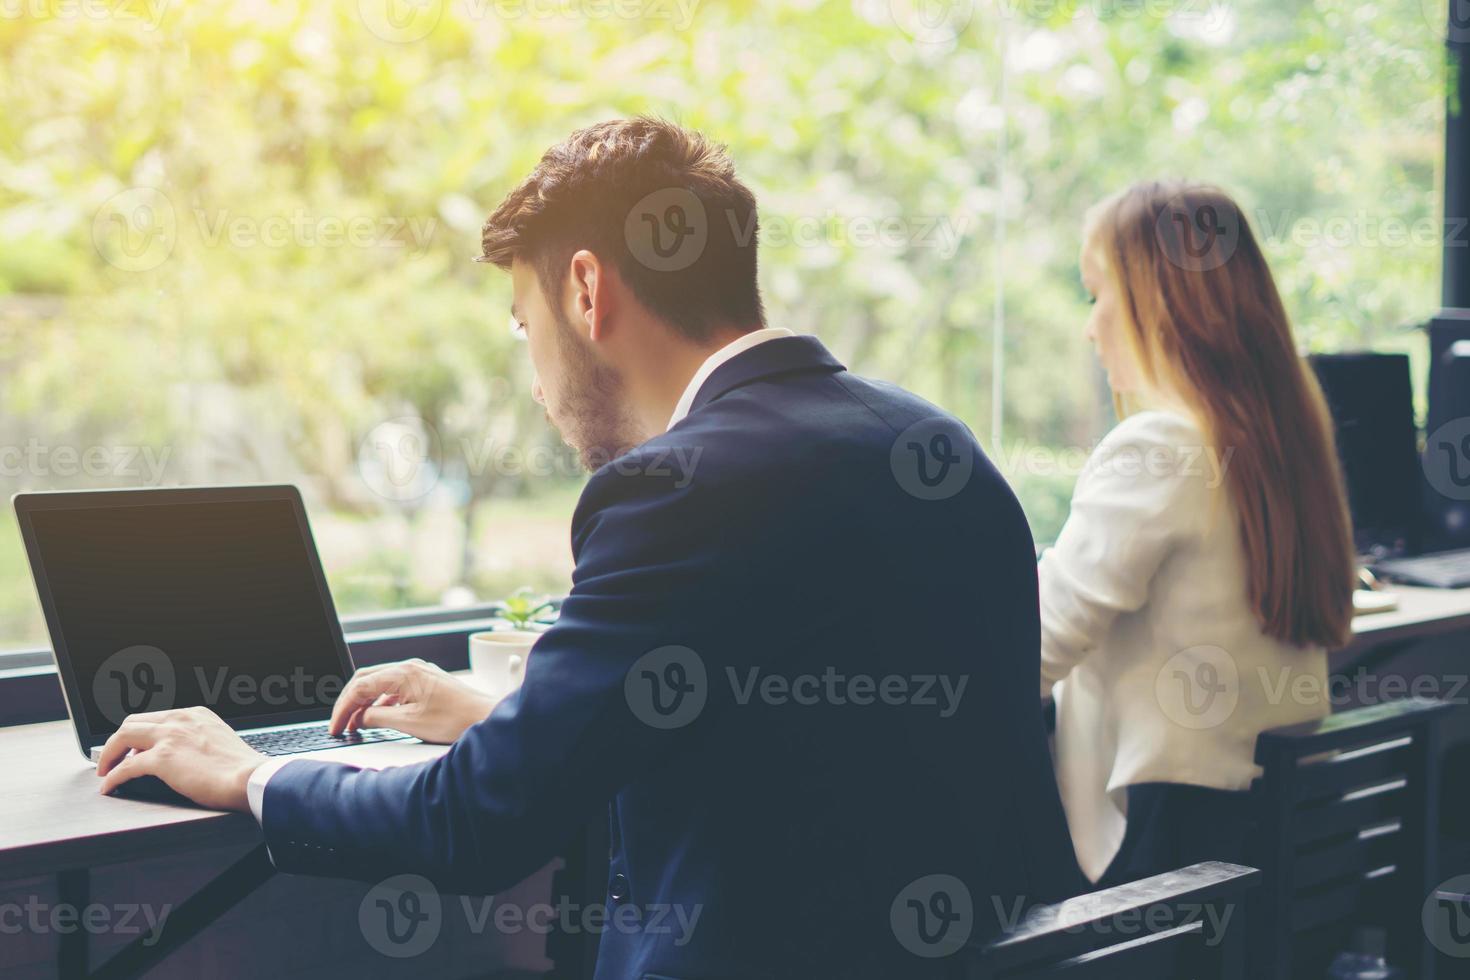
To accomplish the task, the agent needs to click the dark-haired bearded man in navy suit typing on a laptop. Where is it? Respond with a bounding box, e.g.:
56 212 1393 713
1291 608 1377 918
98 119 1076 980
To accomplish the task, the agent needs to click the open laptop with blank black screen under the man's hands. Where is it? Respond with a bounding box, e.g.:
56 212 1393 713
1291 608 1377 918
13 486 444 768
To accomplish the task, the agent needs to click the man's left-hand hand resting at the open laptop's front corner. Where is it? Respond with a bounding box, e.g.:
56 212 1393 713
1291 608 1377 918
97 708 266 811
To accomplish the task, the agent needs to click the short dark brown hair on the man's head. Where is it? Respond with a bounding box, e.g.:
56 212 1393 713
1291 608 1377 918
479 118 764 339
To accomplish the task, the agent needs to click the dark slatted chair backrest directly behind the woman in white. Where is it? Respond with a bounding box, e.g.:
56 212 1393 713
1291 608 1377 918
1251 698 1449 980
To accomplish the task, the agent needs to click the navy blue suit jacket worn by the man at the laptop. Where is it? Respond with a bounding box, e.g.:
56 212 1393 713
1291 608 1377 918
263 336 1078 980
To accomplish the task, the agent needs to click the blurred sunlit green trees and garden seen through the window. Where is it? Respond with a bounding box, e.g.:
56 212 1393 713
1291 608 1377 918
0 0 1446 648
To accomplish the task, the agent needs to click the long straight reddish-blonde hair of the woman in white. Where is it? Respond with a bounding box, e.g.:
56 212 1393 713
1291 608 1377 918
1085 181 1355 648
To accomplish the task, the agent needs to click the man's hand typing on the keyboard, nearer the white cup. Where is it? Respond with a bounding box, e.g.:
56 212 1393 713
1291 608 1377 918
328 660 495 743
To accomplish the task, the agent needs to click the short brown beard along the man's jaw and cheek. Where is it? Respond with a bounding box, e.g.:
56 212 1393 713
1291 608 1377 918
547 312 651 472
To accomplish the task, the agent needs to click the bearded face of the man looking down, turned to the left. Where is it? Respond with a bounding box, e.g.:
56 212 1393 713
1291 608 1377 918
510 259 642 470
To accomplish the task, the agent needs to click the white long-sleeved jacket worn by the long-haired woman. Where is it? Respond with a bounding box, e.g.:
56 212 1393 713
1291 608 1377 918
1039 411 1330 880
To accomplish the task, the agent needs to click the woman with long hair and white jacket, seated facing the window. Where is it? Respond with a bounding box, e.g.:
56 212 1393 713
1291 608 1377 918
1038 182 1354 884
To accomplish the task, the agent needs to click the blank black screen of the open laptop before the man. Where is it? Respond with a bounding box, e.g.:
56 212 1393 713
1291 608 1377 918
31 500 344 735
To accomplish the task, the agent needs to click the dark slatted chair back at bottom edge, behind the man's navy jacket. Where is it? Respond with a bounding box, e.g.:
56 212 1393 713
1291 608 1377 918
963 861 1260 980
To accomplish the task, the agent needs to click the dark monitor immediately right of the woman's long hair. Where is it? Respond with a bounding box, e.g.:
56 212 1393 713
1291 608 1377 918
1308 351 1423 555
